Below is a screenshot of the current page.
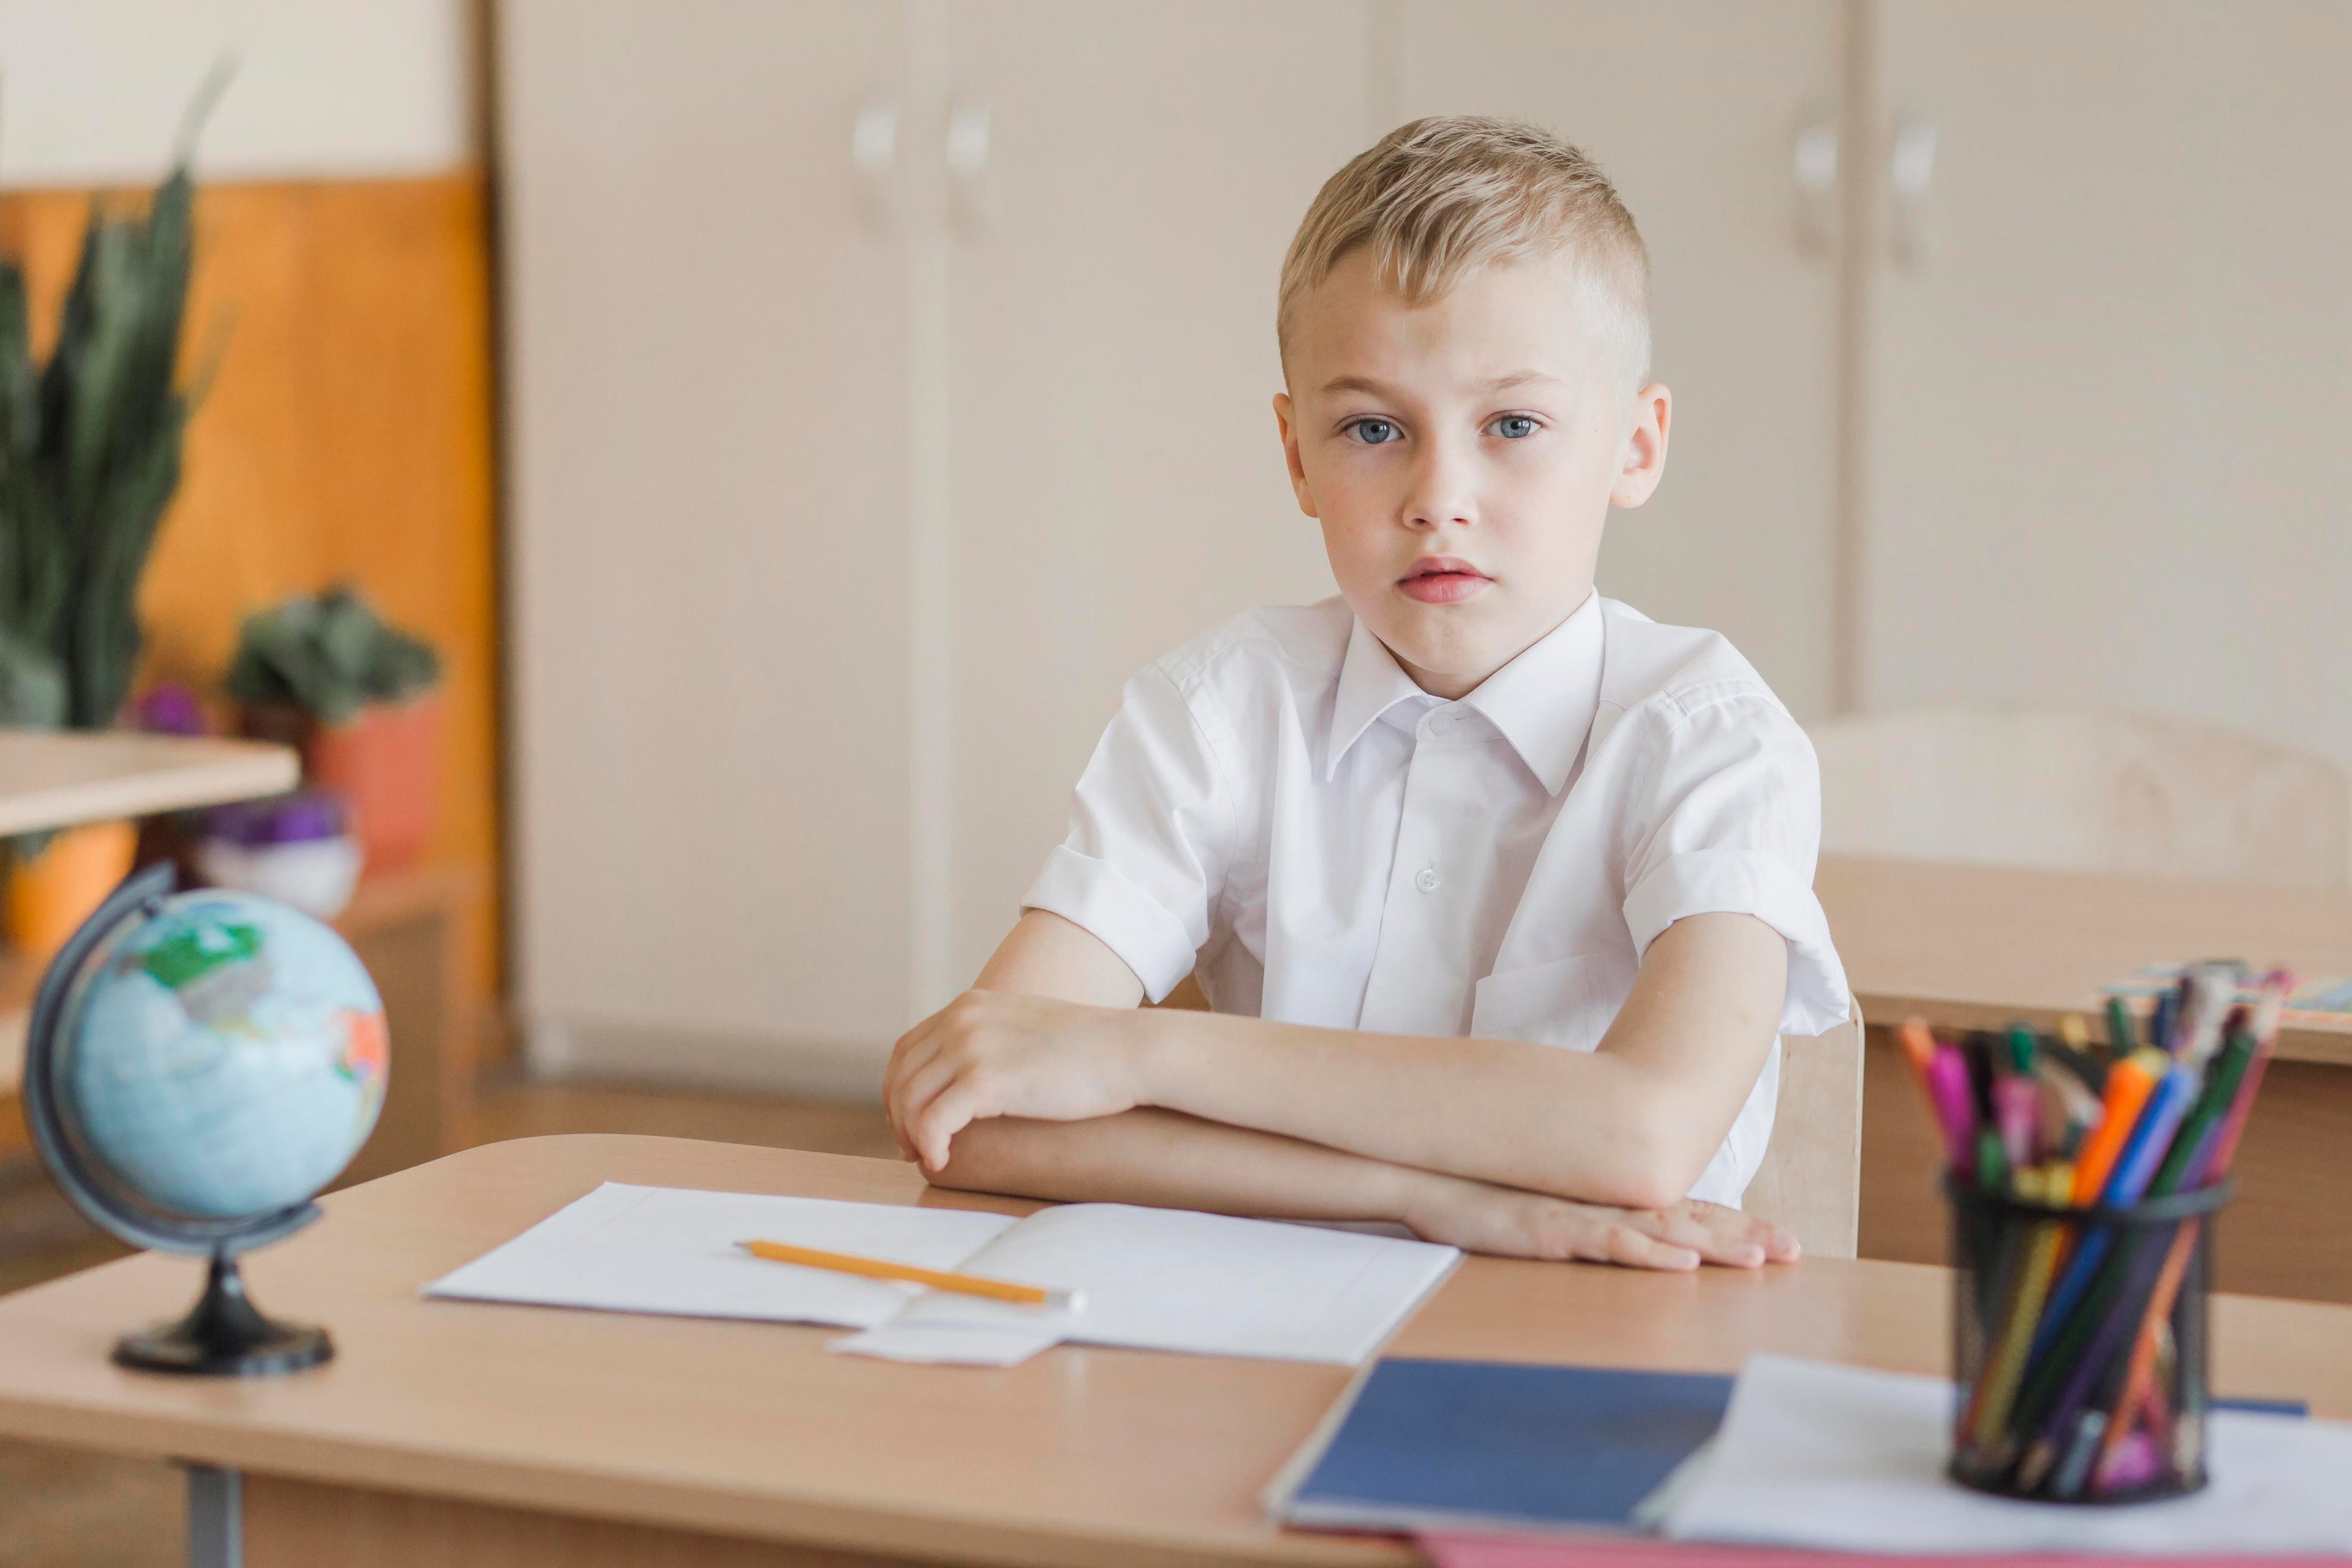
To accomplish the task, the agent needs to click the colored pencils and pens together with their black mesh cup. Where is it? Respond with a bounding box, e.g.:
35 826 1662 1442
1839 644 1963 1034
1898 982 2293 1498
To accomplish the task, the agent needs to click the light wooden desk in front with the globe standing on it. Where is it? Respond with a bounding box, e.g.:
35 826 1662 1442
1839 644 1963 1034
0 1136 2352 1568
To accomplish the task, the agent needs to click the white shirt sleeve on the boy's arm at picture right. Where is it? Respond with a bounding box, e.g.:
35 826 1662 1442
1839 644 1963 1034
1625 689 1851 1035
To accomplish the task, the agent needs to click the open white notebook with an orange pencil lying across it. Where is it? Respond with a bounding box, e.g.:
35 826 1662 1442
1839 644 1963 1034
426 1183 1461 1366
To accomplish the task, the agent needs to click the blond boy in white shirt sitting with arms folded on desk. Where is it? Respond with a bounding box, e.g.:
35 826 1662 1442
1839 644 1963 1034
884 118 1846 1270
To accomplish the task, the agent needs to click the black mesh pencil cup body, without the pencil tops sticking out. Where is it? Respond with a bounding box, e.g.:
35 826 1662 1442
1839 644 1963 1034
1945 1175 2230 1502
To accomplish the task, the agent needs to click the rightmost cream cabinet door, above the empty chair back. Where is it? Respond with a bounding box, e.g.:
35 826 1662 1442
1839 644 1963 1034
1865 0 2352 764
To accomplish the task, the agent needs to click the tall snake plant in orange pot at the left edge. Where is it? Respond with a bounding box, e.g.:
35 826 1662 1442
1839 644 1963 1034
0 157 202 952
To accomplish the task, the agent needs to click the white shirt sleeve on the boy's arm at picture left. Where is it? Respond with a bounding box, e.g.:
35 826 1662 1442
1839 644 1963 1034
1021 665 1235 1001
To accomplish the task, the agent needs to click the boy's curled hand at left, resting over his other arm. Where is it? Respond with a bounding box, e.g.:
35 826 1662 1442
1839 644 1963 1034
882 990 1139 1170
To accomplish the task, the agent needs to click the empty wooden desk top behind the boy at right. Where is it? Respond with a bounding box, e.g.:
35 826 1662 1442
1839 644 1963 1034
1814 856 2352 1065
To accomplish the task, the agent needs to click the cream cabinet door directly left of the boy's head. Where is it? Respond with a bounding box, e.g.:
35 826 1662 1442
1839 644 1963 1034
932 0 1366 992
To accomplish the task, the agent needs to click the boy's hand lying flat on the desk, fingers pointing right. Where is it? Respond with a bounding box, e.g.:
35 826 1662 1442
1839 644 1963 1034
1404 1180 1800 1270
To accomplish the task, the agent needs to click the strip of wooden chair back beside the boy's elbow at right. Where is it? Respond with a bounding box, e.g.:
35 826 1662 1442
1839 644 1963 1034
1741 1004 1863 1257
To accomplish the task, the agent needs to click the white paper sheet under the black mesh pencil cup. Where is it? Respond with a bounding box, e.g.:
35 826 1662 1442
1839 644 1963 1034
1665 1357 2352 1556
